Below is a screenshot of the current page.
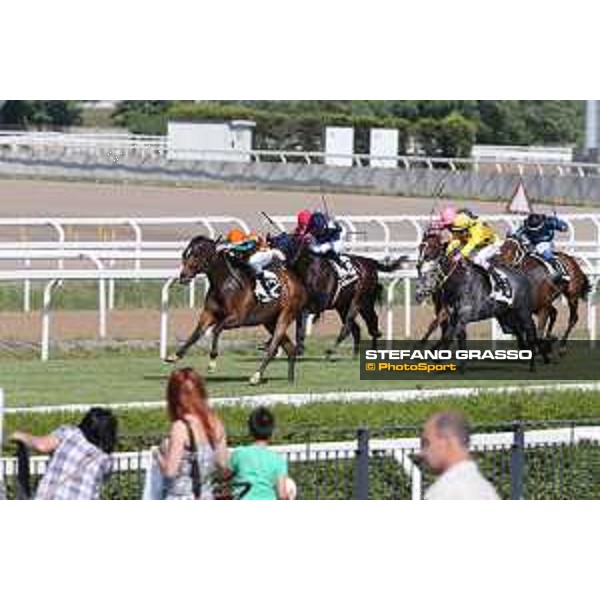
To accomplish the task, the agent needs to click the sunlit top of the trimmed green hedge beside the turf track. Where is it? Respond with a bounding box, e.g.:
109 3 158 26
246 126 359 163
5 391 600 450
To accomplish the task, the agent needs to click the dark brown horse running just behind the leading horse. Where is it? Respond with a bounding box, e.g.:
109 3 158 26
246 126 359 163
269 232 406 358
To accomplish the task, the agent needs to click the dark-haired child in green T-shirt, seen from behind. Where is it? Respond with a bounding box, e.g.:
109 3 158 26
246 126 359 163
230 407 291 500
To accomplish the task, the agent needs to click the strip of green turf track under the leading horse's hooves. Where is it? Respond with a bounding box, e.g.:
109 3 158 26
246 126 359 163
0 344 592 406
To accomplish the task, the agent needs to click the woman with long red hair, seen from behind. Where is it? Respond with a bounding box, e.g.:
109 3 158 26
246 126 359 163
157 368 227 500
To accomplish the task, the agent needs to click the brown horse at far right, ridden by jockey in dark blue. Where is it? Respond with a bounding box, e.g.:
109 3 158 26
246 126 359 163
498 235 591 354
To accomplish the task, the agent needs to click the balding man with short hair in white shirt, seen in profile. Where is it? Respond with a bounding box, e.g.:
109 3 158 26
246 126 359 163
421 411 500 500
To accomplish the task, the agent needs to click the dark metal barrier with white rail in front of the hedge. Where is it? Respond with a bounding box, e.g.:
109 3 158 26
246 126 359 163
0 422 600 500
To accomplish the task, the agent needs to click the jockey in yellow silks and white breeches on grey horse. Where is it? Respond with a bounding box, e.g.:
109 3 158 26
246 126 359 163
446 211 509 302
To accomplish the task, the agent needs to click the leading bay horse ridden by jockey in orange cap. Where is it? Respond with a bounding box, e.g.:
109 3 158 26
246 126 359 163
166 235 307 385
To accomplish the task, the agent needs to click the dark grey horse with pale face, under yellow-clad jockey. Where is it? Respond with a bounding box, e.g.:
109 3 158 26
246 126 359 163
416 229 548 371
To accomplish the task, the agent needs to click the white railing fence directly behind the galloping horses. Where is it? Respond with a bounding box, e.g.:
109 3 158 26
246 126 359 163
0 213 600 360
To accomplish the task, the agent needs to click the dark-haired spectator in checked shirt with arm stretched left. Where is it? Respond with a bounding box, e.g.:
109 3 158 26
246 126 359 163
11 408 117 500
